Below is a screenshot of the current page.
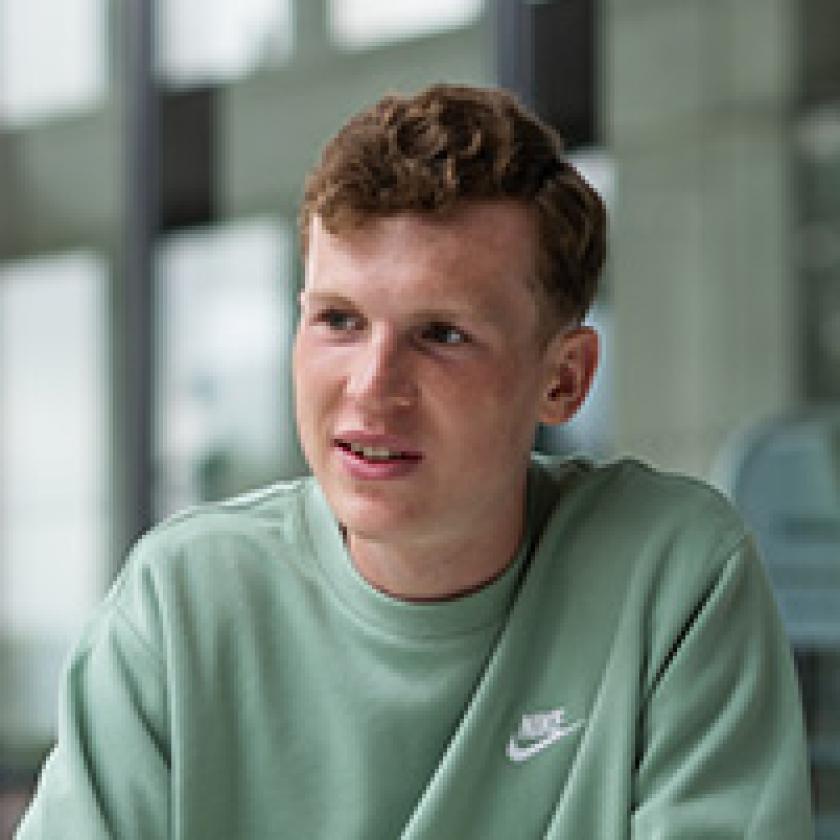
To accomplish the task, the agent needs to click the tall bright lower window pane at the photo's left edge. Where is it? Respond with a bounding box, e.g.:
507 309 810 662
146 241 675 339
0 253 111 740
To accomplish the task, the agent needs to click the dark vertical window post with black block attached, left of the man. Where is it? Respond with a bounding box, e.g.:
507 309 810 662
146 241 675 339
113 0 219 570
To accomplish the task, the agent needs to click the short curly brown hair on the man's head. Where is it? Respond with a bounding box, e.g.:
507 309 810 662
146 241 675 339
298 84 606 328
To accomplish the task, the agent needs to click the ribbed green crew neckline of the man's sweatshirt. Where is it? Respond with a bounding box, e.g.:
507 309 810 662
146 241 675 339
304 467 534 639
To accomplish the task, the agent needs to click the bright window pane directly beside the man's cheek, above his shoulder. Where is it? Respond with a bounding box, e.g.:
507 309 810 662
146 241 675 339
156 215 299 515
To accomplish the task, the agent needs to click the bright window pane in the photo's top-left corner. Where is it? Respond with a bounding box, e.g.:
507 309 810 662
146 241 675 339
0 0 107 124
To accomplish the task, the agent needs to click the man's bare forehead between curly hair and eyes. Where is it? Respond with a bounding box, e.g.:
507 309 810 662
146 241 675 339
302 207 535 325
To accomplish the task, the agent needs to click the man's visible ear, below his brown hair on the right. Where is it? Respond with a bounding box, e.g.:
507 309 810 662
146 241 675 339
539 327 599 426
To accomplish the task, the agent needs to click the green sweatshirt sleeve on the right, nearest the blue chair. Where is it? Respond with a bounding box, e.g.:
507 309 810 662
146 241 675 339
631 539 814 840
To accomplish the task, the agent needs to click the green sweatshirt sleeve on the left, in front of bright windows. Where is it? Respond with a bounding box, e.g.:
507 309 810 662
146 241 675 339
15 556 170 840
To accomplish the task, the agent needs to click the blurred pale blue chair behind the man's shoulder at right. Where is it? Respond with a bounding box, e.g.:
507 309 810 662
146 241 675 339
712 409 840 840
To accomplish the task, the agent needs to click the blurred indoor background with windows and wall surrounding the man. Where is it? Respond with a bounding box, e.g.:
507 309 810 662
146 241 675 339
0 0 840 838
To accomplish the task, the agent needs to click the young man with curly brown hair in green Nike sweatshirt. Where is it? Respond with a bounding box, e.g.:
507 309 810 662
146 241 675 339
19 86 812 840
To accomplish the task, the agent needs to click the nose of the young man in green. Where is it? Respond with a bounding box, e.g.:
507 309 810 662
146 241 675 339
347 331 417 410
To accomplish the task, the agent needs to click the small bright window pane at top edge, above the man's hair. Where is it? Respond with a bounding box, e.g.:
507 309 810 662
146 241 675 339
329 0 484 49
